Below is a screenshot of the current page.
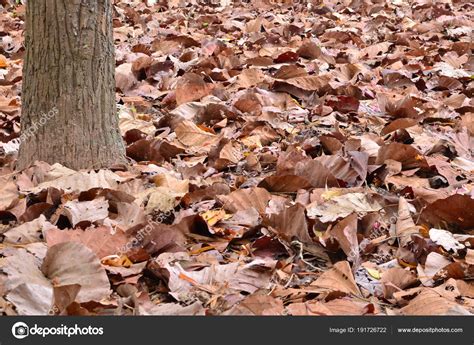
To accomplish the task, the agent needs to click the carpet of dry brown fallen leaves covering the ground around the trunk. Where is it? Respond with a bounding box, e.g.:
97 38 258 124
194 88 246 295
0 0 474 315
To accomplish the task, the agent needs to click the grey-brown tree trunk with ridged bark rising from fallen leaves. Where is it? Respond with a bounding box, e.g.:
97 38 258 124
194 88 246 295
17 0 125 169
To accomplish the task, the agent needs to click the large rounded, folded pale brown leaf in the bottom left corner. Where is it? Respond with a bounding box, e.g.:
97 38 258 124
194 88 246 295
3 242 110 315
